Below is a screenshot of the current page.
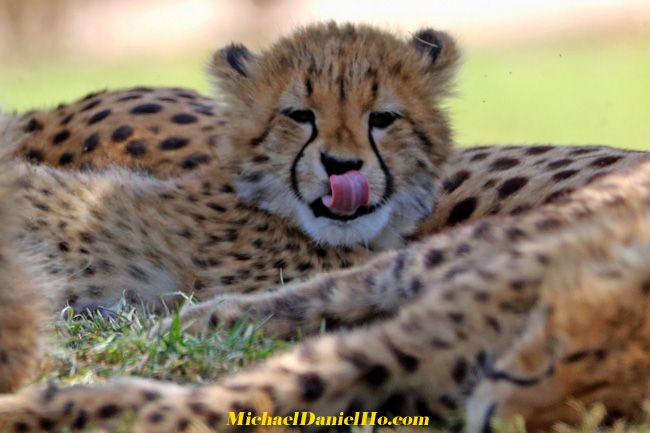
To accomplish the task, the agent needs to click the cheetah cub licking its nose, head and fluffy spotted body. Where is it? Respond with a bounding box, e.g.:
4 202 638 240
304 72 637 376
0 23 459 390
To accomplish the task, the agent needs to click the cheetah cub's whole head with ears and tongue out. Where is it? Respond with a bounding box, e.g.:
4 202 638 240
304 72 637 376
211 23 459 247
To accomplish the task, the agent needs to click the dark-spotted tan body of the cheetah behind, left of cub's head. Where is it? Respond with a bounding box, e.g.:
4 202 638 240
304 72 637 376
4 87 224 177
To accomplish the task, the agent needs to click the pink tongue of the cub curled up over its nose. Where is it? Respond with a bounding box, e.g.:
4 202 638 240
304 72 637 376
322 170 370 215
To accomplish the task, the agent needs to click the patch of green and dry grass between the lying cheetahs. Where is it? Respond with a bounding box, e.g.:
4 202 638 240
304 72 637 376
37 307 289 383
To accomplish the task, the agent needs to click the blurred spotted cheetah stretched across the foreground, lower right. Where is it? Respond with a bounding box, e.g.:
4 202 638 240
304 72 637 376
0 160 650 432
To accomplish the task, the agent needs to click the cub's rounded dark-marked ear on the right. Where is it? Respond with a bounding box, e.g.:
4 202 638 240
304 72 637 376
411 29 460 82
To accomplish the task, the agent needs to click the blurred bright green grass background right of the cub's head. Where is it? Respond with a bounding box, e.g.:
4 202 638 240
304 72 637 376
451 38 650 150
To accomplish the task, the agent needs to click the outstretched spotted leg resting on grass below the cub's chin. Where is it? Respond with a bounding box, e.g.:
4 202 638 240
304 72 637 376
153 248 408 338
